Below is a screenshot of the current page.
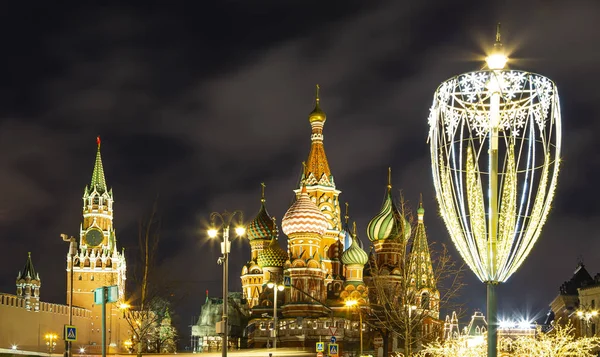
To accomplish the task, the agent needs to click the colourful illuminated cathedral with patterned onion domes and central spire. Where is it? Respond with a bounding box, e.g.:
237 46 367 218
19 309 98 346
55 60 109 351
241 86 439 349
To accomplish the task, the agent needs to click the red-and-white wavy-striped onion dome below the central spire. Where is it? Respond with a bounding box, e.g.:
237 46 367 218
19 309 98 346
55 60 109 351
281 185 328 236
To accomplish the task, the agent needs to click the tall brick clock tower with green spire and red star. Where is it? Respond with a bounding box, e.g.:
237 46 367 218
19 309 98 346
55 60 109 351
67 137 127 346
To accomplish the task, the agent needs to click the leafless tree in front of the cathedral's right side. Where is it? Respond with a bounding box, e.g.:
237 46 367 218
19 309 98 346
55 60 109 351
365 196 465 356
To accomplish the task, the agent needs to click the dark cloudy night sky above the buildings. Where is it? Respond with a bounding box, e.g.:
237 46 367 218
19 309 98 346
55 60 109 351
0 0 600 340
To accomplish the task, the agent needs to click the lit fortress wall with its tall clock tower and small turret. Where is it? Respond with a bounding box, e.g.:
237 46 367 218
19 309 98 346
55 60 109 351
0 139 129 354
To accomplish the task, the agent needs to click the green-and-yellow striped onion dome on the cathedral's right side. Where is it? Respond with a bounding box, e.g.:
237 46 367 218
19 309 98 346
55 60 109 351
367 168 411 242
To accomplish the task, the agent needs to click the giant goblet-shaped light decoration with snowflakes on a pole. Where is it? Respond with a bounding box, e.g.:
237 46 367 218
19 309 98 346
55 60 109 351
429 25 561 357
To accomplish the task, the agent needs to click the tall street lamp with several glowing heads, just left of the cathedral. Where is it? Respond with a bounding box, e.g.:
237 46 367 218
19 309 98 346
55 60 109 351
207 211 246 357
